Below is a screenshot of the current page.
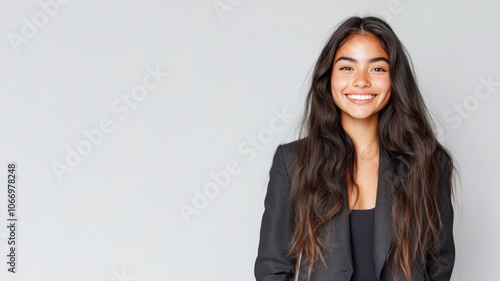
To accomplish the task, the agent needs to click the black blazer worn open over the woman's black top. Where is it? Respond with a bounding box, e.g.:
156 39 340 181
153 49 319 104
254 141 455 281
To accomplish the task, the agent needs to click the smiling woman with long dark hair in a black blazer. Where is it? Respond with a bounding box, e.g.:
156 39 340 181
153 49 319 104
255 17 455 281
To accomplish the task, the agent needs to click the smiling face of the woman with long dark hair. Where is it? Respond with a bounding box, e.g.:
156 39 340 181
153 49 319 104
331 33 391 122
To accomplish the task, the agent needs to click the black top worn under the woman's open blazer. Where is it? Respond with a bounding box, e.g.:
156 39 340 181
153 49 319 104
349 208 377 281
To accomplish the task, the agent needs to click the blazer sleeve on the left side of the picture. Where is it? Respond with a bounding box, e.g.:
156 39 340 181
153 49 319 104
254 144 294 281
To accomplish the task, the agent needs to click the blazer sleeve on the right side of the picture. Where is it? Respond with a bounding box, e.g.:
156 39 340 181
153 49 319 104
427 153 455 281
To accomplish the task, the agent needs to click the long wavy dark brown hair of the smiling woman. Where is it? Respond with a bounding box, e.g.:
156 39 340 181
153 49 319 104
289 17 455 280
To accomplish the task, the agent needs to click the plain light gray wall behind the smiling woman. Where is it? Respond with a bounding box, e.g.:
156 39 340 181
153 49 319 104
0 0 500 281
